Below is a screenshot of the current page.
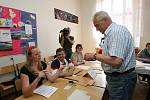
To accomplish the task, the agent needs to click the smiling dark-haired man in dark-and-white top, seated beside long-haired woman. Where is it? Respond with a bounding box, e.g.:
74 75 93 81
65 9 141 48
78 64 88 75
51 48 74 77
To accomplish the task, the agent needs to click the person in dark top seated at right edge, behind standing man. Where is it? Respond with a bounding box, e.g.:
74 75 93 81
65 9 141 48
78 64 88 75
136 43 150 63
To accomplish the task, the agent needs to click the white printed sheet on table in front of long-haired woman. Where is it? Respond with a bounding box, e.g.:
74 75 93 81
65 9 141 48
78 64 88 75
33 85 58 98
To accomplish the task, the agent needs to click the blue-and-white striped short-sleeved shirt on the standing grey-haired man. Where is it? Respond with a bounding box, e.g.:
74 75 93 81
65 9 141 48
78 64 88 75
102 23 136 73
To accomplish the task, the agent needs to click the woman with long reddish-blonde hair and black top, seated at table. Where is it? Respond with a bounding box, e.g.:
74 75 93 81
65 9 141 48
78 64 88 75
20 46 63 97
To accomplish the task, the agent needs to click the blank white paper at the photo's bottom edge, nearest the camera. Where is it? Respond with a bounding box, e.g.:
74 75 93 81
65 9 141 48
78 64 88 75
67 89 90 100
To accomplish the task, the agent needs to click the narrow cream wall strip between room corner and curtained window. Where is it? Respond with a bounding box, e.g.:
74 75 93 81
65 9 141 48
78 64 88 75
81 0 96 52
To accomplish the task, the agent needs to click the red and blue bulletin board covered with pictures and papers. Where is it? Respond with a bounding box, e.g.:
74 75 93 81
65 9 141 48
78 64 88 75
0 6 37 56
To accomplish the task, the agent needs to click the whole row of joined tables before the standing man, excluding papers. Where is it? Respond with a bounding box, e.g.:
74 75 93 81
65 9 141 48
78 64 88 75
15 61 106 100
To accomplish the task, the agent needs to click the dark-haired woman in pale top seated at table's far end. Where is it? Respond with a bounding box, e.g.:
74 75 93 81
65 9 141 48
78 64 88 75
71 44 85 66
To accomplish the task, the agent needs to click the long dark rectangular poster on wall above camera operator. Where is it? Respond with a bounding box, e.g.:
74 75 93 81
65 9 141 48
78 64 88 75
54 8 78 24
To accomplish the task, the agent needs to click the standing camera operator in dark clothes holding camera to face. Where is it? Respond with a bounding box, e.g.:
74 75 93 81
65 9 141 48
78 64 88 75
59 27 75 60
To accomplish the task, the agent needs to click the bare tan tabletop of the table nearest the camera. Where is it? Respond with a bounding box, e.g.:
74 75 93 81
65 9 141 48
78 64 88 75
15 78 104 100
